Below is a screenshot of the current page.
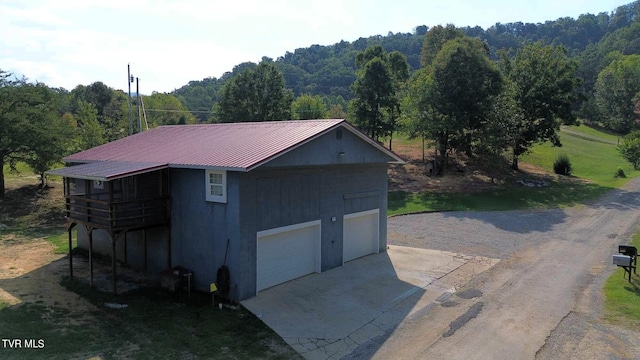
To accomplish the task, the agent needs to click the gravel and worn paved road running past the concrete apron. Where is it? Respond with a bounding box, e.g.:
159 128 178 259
378 179 640 359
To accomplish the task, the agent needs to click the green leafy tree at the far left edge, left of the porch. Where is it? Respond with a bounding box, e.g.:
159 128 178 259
0 70 66 198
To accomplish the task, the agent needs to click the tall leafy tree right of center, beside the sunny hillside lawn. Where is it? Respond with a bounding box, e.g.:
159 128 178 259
501 43 580 170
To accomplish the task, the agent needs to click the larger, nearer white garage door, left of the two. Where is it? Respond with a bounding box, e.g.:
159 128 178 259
256 220 320 291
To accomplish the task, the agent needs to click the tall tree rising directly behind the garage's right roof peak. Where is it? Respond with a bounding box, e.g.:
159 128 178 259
350 45 409 147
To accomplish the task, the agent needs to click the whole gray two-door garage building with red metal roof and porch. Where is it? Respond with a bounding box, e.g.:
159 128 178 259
50 119 402 301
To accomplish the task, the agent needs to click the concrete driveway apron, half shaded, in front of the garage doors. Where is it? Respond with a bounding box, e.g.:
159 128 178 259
242 246 499 359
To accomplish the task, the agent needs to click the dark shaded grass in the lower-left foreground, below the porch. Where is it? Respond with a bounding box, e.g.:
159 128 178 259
0 278 298 359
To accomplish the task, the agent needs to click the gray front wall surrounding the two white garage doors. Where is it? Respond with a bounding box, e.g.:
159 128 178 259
231 164 387 299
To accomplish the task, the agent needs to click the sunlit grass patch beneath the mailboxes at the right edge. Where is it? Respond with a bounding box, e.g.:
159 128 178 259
604 231 640 331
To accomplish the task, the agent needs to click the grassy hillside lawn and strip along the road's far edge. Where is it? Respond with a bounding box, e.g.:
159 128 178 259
388 126 640 215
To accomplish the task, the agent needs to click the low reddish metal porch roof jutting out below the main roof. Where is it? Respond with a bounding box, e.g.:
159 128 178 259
47 161 168 181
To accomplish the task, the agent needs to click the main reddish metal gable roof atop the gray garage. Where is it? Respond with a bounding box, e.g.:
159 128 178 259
65 119 402 171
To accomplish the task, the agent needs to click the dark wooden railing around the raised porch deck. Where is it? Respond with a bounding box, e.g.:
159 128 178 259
66 196 170 231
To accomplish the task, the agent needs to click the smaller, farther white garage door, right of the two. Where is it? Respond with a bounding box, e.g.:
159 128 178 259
342 209 380 262
